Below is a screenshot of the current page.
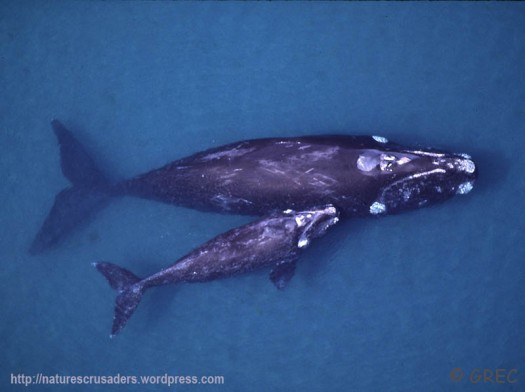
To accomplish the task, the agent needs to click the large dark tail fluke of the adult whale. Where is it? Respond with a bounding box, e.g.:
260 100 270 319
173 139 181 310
29 120 114 254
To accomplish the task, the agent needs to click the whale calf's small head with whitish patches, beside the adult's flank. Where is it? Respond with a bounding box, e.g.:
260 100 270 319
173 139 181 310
283 204 339 248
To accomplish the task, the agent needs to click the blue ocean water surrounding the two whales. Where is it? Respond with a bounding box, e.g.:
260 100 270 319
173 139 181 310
0 1 525 391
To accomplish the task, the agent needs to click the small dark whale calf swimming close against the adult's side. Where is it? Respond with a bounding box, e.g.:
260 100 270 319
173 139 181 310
93 205 339 336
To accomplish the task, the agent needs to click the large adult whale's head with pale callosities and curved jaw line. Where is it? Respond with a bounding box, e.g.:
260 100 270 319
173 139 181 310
356 137 478 215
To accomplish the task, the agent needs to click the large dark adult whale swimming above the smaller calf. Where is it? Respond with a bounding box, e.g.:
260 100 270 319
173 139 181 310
31 120 478 253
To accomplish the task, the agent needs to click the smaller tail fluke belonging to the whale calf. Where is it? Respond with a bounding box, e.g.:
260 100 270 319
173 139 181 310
93 262 146 337
